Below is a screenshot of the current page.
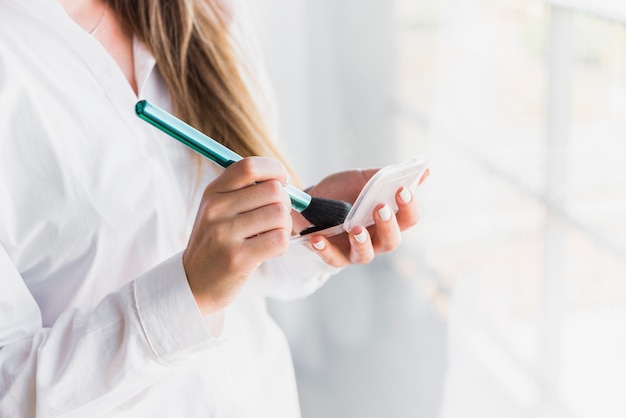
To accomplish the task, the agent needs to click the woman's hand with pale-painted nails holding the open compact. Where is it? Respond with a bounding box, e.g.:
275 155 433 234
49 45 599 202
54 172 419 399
296 169 429 267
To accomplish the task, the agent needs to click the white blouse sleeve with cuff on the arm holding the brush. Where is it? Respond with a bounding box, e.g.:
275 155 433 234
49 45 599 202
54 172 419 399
0 245 219 418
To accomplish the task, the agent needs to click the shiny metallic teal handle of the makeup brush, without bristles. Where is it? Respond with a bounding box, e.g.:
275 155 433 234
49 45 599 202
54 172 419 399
135 100 311 212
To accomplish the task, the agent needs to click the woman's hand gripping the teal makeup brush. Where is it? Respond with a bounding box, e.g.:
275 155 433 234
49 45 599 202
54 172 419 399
183 157 292 315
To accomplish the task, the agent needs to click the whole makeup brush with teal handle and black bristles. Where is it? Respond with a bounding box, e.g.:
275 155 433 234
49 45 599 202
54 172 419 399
135 100 352 230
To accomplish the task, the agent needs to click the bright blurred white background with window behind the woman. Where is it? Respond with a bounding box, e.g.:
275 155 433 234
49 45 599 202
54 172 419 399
243 0 626 418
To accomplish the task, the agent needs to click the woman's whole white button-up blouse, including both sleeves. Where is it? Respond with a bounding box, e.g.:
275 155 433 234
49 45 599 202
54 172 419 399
0 0 336 418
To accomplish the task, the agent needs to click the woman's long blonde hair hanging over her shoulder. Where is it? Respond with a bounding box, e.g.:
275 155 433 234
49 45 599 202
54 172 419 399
107 0 294 175
